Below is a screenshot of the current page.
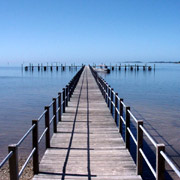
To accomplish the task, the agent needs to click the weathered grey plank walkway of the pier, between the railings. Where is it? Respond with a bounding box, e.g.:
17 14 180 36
33 67 141 180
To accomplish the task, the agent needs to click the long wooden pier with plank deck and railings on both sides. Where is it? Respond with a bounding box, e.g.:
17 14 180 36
0 66 180 180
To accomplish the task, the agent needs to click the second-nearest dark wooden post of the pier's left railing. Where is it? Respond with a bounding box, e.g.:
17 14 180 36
32 120 39 174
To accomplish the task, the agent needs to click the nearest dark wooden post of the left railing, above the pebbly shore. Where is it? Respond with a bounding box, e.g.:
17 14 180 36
8 144 19 180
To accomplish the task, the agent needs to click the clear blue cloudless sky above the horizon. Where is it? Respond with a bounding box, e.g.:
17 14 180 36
0 0 180 63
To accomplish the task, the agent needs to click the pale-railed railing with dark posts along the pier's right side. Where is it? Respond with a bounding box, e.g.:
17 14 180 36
90 66 180 179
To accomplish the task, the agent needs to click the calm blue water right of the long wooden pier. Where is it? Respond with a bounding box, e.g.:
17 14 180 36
101 64 180 179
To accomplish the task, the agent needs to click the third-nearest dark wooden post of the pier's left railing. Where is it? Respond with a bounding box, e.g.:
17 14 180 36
45 106 50 149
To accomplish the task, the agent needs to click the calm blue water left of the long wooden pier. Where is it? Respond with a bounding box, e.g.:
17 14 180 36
0 67 77 159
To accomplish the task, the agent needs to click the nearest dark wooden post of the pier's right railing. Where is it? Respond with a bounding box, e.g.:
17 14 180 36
156 144 165 180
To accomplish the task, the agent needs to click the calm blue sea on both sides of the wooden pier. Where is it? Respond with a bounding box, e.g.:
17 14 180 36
0 64 180 179
